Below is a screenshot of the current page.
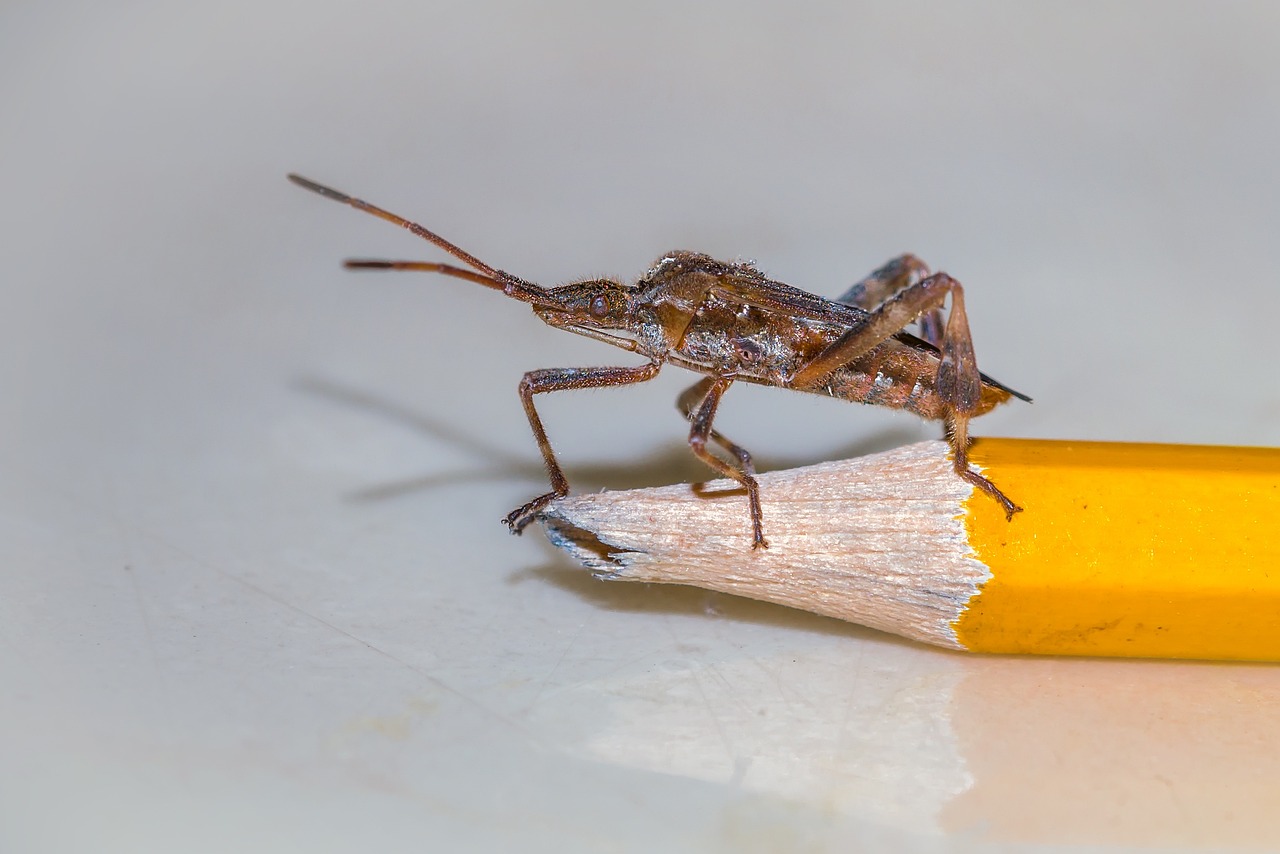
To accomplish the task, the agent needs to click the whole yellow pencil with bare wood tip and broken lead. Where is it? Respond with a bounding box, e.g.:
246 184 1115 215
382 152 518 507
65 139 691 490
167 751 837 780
541 439 1280 661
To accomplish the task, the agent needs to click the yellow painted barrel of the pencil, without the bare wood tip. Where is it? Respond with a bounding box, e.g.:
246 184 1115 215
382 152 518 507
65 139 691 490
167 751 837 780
954 439 1280 661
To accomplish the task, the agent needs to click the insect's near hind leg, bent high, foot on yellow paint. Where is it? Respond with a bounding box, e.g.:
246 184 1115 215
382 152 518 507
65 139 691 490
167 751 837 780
790 273 1021 519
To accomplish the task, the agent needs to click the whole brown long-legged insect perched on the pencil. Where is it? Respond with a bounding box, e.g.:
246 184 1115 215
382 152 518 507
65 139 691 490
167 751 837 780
289 175 1030 548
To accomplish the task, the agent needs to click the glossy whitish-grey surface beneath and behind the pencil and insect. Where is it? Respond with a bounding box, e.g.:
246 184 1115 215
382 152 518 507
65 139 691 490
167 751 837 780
0 0 1280 851
